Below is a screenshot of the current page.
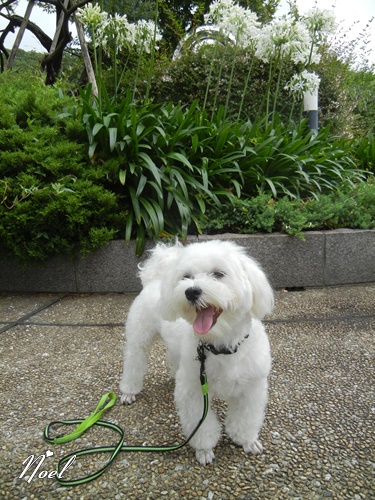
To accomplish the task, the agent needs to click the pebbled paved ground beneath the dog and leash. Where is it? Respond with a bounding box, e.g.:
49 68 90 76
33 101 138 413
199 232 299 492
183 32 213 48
0 285 375 500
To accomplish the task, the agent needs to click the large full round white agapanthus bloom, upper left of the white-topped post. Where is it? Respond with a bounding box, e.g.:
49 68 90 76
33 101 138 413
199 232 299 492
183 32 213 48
255 17 318 64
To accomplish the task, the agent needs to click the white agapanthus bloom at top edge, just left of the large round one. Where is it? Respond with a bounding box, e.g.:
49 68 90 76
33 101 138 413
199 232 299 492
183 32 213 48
204 0 260 50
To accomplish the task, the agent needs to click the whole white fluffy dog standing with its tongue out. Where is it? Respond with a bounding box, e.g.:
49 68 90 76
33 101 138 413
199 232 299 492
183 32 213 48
120 240 273 465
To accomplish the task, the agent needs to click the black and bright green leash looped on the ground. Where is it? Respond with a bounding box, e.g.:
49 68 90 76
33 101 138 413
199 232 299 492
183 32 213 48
44 342 209 486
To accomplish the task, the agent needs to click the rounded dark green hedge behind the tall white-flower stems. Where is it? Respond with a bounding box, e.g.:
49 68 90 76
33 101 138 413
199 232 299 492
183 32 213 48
138 46 301 121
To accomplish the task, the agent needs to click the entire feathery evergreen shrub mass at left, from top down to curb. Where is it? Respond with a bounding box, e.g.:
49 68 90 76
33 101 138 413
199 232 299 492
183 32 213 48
0 72 125 262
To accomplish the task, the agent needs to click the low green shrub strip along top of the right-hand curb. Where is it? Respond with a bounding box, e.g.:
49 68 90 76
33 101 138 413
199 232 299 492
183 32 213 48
199 177 375 236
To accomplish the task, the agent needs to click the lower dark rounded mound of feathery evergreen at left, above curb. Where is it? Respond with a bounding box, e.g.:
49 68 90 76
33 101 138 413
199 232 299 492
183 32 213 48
0 174 123 262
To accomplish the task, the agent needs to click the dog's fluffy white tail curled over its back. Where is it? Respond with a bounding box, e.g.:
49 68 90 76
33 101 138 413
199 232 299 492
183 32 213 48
138 239 183 287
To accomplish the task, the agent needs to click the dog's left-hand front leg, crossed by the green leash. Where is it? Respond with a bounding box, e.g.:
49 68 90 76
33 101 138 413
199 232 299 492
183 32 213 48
174 364 221 465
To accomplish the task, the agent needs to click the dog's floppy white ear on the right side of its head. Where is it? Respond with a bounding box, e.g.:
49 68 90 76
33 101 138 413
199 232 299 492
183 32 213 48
240 254 274 319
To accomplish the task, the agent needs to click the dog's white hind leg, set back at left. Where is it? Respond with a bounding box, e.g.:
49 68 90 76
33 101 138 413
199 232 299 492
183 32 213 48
120 287 160 404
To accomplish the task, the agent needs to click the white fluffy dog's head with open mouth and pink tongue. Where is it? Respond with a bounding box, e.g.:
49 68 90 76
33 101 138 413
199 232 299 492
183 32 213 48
160 240 273 338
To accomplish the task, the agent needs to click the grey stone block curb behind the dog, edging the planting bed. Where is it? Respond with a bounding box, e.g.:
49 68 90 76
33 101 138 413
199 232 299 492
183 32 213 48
0 229 375 293
